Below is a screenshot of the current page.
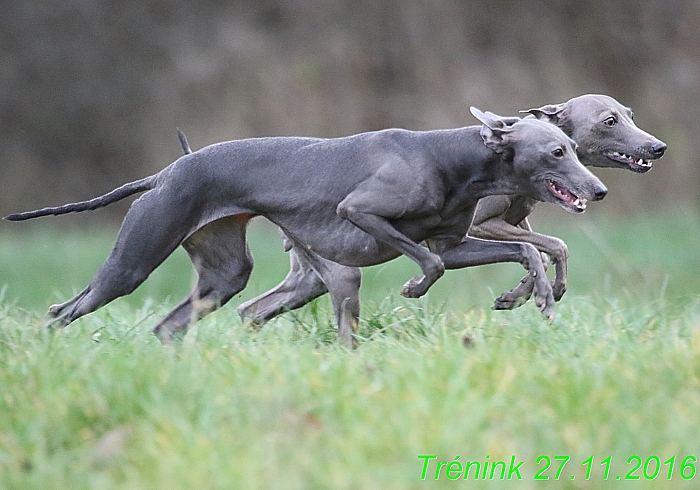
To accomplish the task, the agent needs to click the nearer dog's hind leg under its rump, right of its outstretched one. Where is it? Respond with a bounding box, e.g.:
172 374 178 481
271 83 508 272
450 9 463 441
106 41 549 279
153 215 253 343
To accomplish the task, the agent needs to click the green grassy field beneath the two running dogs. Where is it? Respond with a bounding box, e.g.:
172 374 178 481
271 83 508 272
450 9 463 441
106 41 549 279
0 208 700 489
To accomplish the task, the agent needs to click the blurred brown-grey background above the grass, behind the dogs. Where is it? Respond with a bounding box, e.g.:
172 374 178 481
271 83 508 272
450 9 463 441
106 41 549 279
0 0 700 219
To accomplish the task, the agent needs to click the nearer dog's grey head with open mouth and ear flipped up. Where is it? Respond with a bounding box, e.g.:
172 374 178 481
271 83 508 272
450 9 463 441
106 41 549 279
471 107 608 213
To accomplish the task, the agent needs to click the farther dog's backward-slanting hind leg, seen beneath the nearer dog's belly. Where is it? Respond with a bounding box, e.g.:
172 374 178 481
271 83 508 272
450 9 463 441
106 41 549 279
238 248 328 325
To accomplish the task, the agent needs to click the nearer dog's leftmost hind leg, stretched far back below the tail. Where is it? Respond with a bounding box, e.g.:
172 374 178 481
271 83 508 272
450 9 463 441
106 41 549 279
46 192 194 327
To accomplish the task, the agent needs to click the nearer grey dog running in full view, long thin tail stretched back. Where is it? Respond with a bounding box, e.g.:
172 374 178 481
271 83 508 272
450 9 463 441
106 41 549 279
6 108 607 343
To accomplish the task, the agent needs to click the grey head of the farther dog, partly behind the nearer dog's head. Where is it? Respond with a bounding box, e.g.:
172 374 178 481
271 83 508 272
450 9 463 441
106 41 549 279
522 94 666 173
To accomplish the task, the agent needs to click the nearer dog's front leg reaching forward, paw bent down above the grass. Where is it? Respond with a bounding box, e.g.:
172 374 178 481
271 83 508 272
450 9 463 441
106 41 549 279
440 236 554 317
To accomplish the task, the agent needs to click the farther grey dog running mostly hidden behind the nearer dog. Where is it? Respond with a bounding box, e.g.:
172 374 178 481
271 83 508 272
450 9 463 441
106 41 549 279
238 94 666 324
